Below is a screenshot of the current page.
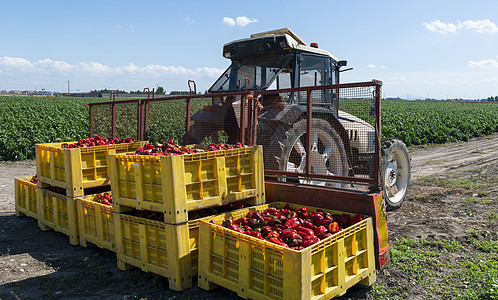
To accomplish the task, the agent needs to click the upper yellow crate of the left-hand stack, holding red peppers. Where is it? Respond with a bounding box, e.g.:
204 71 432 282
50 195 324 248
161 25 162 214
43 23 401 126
35 142 145 197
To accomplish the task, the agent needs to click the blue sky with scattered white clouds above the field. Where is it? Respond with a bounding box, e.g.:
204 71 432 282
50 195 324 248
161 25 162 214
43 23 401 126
0 0 498 98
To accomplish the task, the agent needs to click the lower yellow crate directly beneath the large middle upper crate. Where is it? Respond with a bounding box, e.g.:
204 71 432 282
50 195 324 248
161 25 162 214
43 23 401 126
114 213 204 291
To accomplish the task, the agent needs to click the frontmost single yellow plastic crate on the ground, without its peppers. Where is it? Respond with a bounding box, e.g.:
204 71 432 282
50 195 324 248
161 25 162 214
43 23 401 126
198 203 376 300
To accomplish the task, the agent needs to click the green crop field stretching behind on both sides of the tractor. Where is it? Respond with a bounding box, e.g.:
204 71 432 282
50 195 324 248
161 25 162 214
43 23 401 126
0 96 498 160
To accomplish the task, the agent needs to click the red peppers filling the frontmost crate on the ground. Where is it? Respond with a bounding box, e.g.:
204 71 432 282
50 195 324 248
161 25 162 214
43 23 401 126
210 204 363 250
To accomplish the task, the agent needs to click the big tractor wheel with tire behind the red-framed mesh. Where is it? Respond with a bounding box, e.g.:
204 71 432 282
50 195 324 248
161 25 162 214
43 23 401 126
276 118 349 187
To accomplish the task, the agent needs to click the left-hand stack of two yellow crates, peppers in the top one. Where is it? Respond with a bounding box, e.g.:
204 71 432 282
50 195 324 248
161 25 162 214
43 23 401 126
35 142 144 245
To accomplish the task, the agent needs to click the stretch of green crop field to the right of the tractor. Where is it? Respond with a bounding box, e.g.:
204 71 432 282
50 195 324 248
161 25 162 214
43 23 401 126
382 101 498 146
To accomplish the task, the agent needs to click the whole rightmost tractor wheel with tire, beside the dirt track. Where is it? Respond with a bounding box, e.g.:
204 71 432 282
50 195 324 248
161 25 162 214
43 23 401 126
381 139 411 210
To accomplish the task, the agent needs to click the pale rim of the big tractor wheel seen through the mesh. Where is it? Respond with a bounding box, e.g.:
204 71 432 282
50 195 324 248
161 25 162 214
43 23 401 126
287 129 343 186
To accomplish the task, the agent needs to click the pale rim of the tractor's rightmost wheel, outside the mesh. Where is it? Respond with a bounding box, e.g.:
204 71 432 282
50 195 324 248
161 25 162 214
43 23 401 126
384 149 409 203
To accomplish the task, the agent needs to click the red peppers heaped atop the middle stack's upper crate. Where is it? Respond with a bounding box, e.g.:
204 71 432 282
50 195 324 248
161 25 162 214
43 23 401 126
128 139 244 156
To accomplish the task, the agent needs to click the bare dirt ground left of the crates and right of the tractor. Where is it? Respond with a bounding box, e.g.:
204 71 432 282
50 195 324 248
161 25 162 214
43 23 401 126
0 133 498 299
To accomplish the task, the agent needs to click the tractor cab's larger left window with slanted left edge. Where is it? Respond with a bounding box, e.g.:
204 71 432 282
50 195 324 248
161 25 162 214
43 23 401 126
209 54 294 93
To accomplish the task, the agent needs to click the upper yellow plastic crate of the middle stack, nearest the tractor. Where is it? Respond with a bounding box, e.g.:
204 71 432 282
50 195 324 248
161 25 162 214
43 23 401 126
110 146 265 224
